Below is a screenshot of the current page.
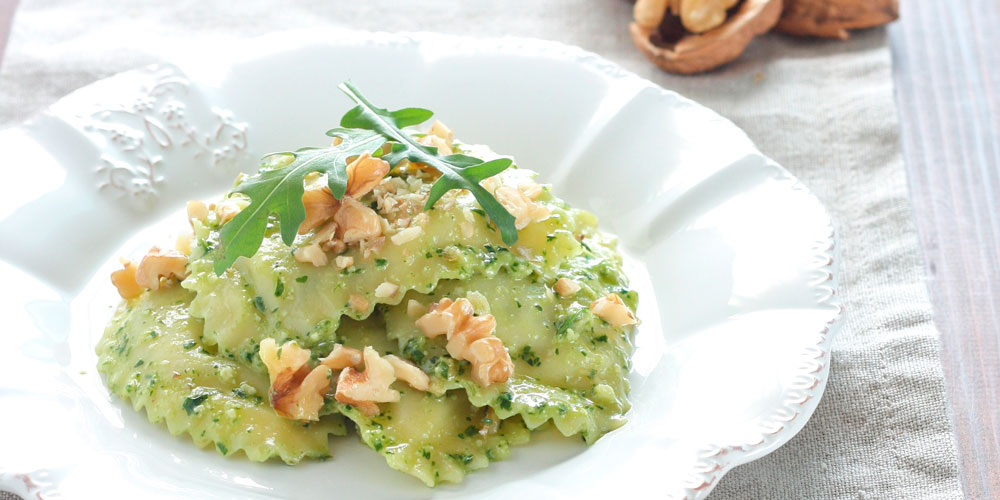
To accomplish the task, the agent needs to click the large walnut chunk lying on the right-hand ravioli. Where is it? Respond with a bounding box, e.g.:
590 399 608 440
416 298 514 387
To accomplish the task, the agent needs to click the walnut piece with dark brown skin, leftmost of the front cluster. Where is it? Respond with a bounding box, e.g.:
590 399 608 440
260 338 332 421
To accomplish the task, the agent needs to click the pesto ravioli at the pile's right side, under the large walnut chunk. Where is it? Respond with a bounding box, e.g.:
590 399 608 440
386 266 633 442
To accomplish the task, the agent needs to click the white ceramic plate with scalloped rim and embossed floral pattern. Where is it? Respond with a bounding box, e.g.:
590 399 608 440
0 31 841 499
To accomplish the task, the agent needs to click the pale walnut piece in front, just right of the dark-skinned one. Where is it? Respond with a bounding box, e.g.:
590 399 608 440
334 347 399 417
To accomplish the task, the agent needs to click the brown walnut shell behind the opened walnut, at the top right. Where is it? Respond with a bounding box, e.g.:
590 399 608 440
774 0 899 40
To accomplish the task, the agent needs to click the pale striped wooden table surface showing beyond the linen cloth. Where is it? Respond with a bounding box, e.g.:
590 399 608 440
0 0 1000 498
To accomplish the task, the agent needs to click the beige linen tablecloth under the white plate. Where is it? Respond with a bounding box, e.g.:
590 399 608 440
0 0 961 499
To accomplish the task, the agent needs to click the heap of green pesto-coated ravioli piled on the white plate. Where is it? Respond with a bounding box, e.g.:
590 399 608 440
97 125 637 486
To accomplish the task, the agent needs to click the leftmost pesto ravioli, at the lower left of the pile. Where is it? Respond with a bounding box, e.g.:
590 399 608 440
97 286 346 464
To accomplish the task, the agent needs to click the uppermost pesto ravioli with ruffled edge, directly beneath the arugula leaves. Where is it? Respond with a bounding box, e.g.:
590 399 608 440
183 199 527 372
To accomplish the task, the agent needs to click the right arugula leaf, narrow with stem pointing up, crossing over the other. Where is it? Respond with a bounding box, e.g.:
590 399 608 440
339 82 517 245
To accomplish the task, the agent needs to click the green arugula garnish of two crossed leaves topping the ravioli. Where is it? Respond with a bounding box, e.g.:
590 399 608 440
214 82 517 275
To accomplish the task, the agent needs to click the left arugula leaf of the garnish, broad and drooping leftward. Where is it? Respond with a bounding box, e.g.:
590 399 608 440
215 128 385 274
